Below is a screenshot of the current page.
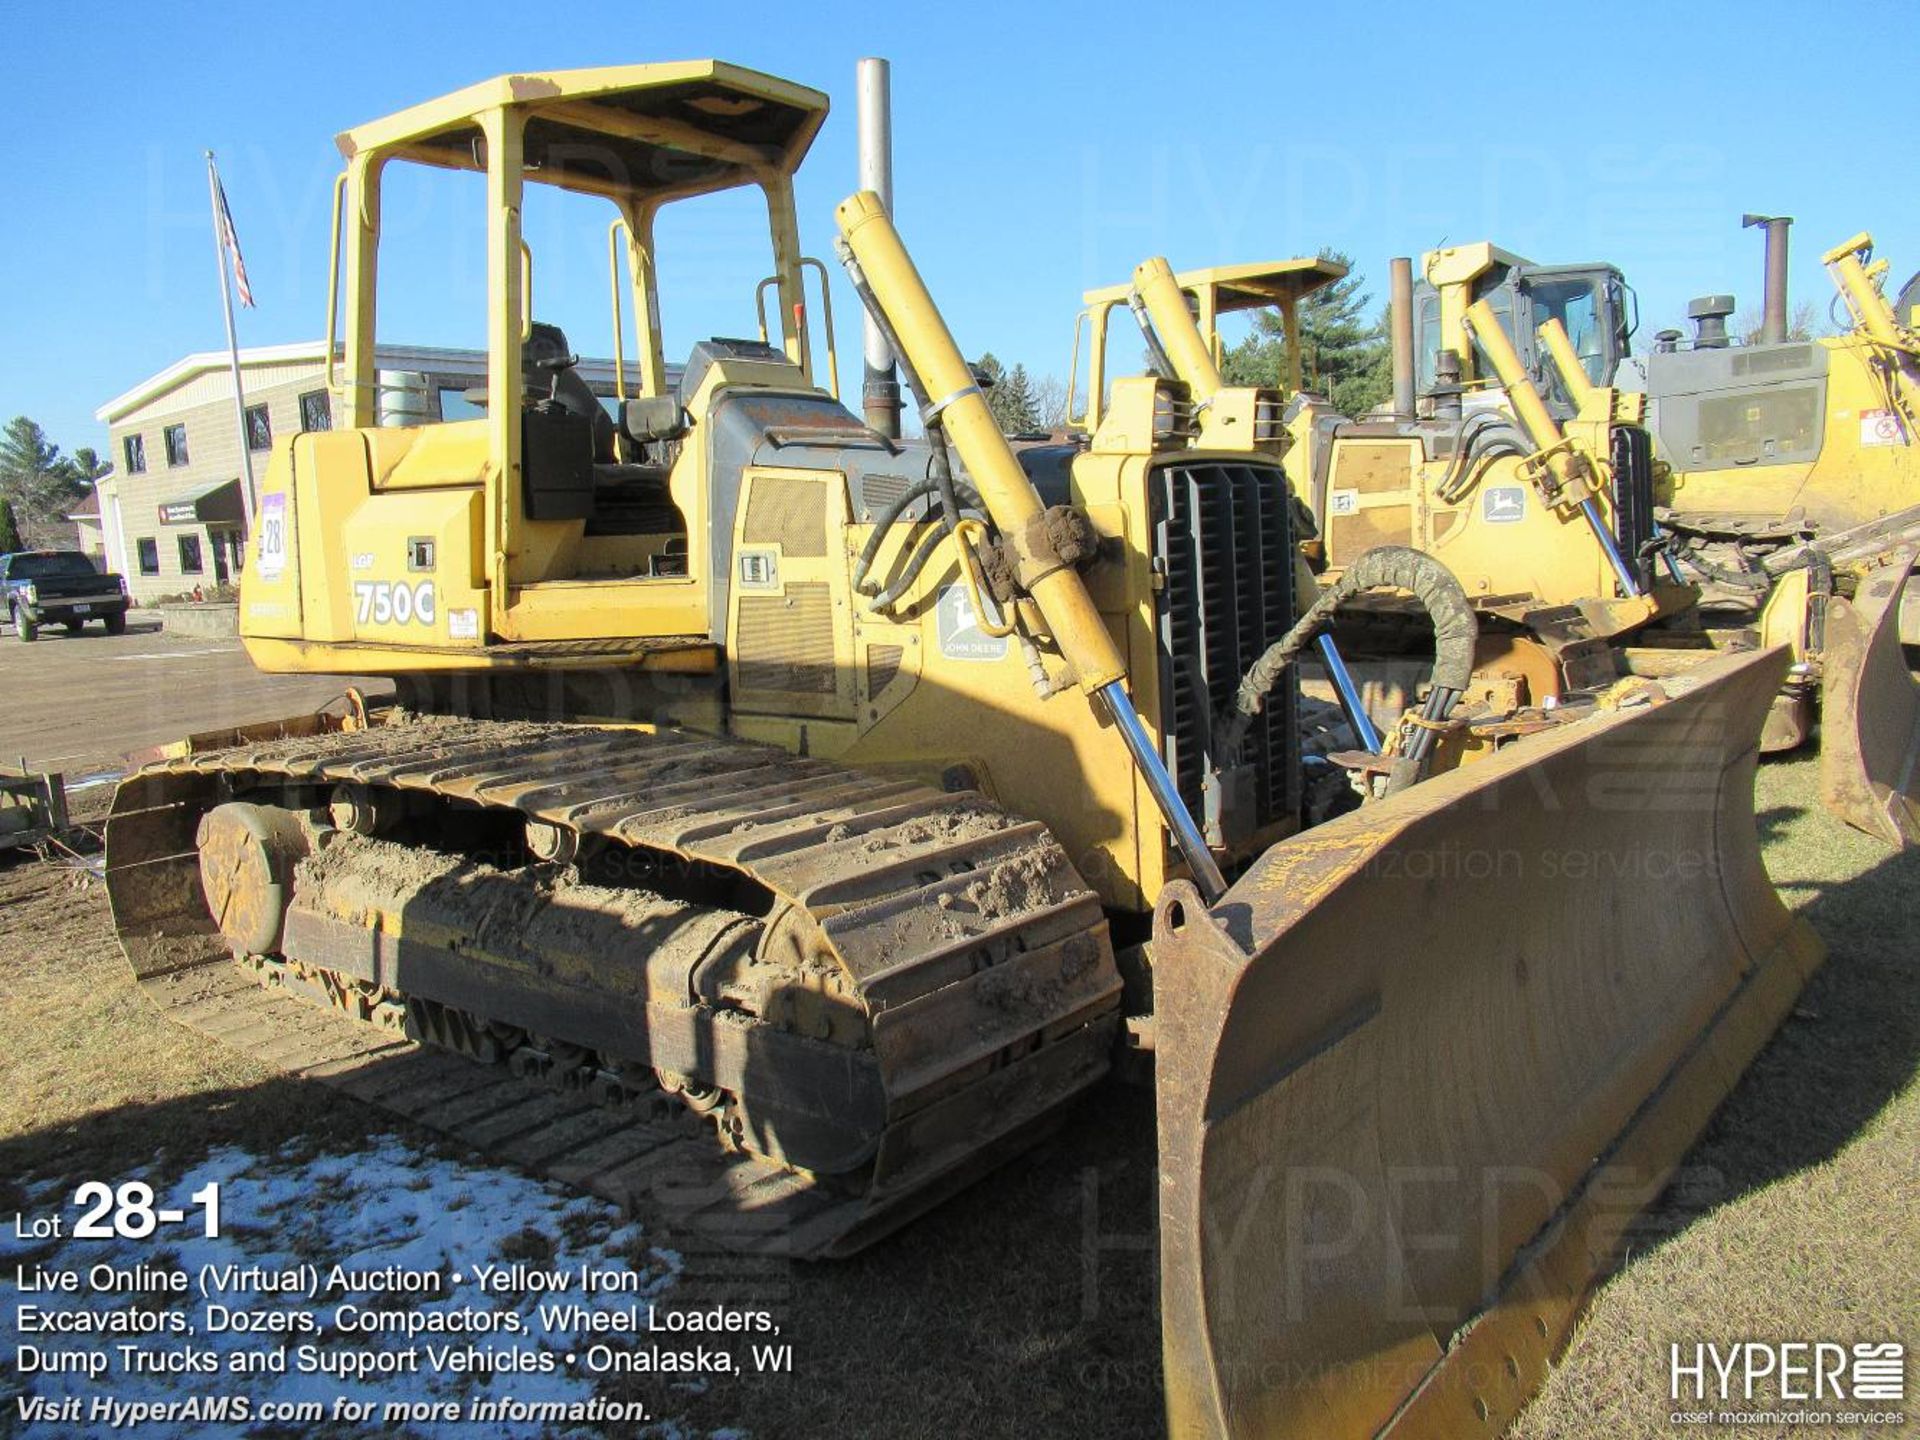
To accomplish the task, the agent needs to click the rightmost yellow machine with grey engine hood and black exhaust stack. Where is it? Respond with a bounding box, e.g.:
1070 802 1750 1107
1632 215 1920 845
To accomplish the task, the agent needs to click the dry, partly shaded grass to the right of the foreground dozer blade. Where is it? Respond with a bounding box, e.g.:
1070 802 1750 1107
1511 760 1920 1440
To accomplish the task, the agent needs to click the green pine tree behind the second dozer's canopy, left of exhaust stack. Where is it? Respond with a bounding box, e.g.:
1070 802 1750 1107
1221 250 1394 415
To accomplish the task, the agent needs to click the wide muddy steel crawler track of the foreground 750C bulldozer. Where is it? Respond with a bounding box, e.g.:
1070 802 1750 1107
108 720 1119 1256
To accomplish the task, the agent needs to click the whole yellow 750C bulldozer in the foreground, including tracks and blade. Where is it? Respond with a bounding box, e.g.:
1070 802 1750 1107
106 61 1820 1436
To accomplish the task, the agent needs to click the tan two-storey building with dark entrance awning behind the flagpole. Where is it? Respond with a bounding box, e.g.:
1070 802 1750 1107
93 340 633 605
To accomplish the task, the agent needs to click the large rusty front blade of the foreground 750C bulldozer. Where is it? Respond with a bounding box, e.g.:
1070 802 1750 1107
1154 649 1822 1440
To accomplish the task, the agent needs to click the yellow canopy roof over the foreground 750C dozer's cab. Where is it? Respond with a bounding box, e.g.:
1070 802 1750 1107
334 60 828 196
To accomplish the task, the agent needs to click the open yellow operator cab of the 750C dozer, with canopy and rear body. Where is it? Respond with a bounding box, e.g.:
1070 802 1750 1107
242 61 831 674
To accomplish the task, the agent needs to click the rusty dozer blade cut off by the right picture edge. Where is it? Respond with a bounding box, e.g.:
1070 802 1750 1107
1820 549 1920 849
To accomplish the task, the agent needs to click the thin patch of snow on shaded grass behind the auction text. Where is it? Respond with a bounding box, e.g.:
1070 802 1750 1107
0 1135 737 1440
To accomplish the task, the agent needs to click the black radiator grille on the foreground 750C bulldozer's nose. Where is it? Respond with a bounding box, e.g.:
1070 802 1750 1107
1148 461 1300 844
